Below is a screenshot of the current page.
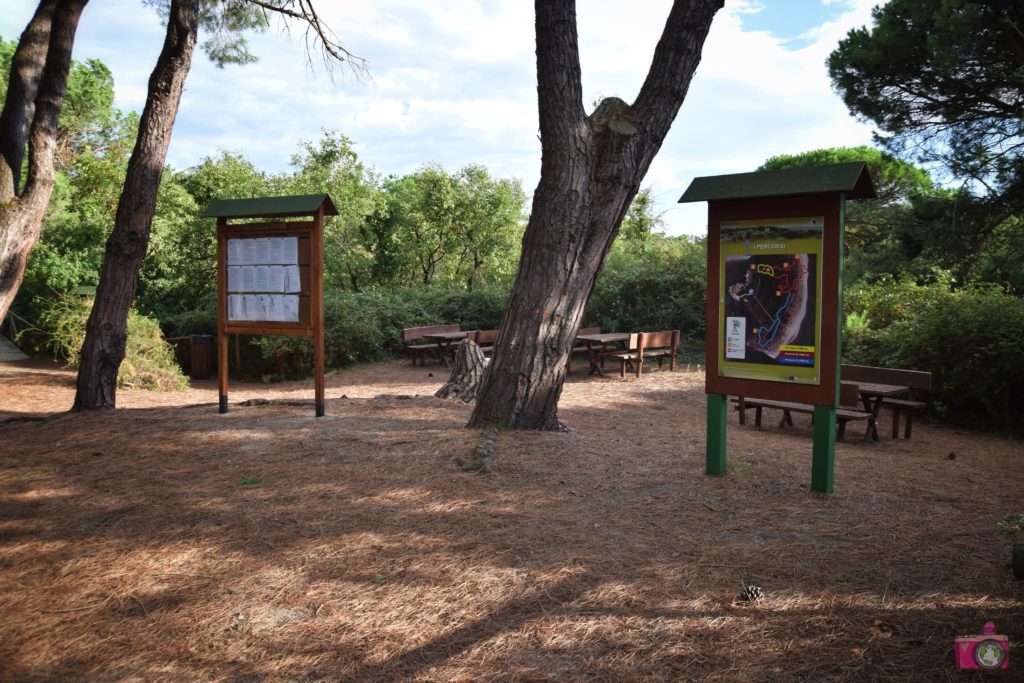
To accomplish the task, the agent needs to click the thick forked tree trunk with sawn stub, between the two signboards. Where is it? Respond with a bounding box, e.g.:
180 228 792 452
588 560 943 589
469 0 723 429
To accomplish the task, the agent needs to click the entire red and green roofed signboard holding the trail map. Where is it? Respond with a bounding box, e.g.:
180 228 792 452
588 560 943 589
679 162 874 494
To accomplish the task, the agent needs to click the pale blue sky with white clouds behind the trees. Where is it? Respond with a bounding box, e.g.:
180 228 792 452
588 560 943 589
0 0 883 236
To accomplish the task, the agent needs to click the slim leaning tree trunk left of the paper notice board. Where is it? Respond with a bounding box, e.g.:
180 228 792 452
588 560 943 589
73 0 200 410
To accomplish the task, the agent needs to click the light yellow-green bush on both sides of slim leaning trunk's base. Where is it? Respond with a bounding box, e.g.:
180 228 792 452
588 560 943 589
40 295 188 391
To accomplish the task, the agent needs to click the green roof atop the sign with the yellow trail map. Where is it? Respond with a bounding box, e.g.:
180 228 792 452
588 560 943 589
679 161 876 203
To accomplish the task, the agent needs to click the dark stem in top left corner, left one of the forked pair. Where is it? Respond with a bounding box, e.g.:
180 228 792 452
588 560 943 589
0 0 57 206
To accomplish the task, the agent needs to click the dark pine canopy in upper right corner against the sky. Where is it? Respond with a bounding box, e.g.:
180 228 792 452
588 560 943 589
828 0 1024 201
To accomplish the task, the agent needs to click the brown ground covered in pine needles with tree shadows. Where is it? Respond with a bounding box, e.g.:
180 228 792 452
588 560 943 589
0 361 1024 682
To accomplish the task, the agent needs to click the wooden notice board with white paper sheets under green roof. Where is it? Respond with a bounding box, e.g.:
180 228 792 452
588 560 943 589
195 195 338 417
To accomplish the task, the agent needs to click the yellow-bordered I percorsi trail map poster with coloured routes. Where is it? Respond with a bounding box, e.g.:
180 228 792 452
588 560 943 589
718 216 824 384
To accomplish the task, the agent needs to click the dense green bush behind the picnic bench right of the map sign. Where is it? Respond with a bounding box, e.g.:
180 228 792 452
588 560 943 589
843 280 1024 431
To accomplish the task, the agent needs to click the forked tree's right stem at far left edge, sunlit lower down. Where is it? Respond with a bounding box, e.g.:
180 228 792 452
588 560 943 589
0 0 88 319
